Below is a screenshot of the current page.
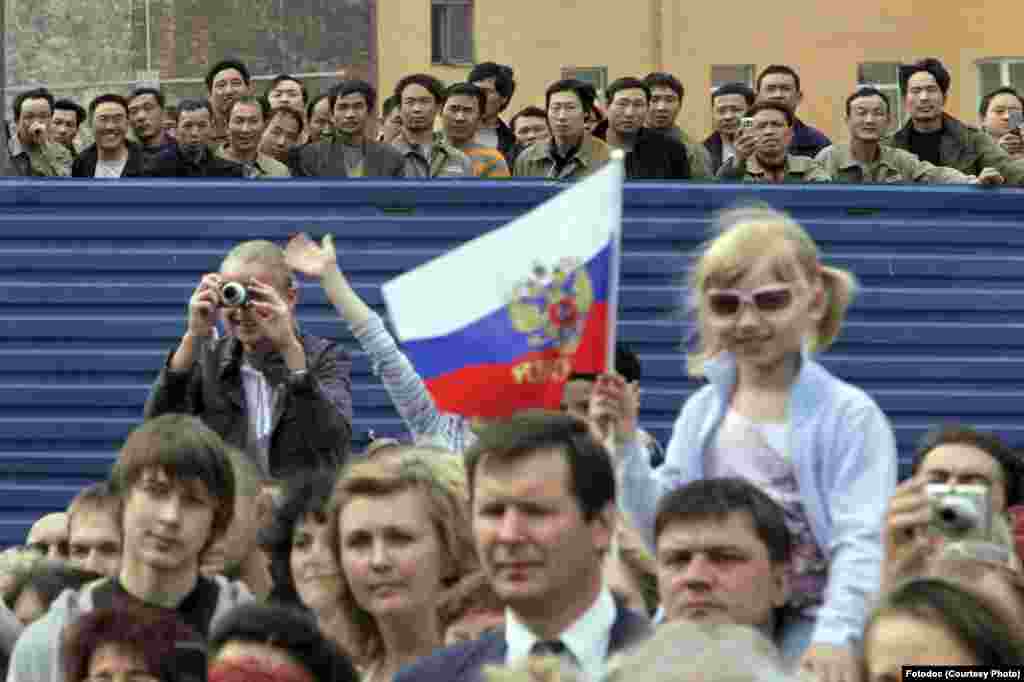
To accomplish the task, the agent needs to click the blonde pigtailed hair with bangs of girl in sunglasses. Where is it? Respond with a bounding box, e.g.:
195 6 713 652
687 207 856 376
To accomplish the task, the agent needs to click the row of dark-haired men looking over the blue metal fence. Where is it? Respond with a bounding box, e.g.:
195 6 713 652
0 58 1024 185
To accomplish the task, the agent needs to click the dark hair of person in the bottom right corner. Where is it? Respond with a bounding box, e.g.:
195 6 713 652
863 578 1024 667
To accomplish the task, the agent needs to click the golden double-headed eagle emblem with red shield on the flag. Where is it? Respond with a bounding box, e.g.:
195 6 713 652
508 258 594 354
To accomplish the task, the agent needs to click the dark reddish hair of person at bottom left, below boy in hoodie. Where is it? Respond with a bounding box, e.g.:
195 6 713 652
60 604 202 682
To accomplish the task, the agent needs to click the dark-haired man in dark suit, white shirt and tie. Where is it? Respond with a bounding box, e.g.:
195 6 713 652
395 413 650 682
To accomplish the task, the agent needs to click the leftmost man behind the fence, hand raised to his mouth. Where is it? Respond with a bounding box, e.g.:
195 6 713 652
7 88 72 177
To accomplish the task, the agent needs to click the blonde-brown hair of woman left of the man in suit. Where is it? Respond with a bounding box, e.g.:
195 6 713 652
330 446 479 665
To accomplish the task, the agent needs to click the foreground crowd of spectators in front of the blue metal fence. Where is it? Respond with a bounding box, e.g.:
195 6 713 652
0 202 1024 682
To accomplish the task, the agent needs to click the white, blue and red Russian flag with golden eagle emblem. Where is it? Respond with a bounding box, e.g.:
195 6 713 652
383 154 624 418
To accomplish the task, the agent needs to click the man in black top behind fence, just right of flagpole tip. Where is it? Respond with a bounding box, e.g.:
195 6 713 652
593 78 696 180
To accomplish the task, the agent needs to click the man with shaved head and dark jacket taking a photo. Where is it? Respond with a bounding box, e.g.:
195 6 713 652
145 241 352 478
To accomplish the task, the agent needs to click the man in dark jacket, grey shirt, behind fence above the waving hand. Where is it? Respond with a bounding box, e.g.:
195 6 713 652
294 80 406 177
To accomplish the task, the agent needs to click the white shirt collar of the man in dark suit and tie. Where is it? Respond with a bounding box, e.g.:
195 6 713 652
505 587 617 681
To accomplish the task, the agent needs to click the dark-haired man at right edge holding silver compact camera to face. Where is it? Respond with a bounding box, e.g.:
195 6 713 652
883 425 1024 584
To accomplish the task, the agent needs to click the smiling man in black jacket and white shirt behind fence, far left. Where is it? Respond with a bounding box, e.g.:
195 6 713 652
71 93 145 177
